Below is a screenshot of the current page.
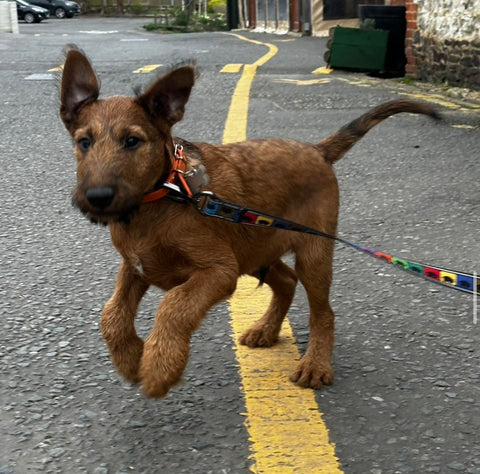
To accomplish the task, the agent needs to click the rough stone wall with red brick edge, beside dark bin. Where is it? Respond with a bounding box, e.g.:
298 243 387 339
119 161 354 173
405 0 480 89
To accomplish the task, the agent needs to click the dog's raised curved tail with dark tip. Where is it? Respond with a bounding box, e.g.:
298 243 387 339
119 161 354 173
315 99 440 163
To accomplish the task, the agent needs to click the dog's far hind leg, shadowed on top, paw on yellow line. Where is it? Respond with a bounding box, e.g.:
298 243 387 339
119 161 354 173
239 260 297 347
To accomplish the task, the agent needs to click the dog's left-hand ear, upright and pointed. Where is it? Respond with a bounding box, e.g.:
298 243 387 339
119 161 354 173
60 45 100 131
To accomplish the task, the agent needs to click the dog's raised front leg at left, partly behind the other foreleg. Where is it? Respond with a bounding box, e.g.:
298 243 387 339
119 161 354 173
101 262 149 383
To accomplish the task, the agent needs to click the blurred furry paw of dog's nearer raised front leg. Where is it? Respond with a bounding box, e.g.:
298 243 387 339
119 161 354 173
140 338 189 398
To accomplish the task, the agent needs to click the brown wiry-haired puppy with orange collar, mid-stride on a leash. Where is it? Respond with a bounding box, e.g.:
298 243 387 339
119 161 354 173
60 47 436 397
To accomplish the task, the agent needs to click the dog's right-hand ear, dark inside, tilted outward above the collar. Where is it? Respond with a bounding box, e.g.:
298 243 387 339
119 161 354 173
137 65 196 128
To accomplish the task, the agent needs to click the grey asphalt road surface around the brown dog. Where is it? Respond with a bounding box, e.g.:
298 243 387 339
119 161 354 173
0 17 480 474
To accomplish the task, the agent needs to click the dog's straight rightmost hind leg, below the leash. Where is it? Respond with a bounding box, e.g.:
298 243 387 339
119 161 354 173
290 237 334 388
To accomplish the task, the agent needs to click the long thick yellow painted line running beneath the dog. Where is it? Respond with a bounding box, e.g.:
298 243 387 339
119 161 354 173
223 34 342 474
